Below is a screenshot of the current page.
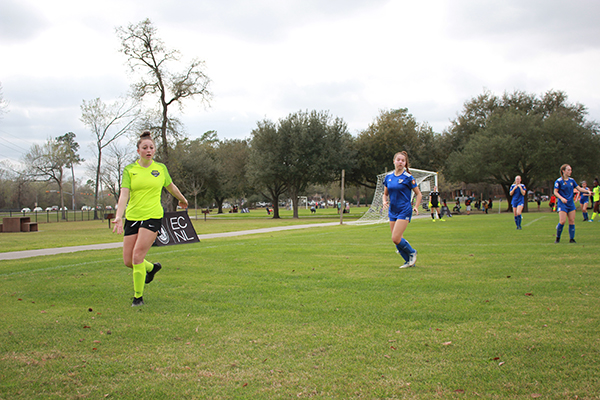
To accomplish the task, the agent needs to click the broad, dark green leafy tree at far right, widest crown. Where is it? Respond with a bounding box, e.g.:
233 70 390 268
444 91 600 210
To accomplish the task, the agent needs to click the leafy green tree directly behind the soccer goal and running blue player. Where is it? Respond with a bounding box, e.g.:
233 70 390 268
348 108 443 189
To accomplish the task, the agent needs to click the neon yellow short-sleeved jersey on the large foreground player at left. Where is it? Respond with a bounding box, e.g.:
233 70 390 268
121 161 173 221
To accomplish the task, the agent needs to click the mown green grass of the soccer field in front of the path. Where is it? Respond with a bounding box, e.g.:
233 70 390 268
0 213 600 399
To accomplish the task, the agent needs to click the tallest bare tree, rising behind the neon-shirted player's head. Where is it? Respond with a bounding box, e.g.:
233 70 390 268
117 19 211 165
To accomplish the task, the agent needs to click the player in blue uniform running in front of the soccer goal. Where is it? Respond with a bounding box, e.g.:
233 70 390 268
383 151 422 268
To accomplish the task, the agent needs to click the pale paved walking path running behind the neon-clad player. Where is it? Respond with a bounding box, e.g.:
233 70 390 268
0 222 340 261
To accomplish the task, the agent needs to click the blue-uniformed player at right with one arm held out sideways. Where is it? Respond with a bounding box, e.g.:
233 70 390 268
554 164 591 243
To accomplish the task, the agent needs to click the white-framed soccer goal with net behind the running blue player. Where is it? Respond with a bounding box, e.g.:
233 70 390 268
349 168 437 225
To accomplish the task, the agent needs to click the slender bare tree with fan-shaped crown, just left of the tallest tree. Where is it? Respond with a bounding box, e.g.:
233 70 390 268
81 97 139 219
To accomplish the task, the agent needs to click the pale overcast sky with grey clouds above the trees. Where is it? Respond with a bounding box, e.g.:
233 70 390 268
0 0 600 177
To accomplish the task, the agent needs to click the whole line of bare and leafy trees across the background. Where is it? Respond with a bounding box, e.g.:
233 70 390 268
0 20 600 218
